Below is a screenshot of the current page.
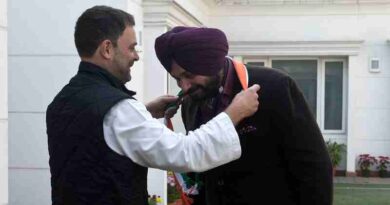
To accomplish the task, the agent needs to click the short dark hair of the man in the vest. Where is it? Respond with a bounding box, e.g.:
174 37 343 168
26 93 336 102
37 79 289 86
74 6 135 57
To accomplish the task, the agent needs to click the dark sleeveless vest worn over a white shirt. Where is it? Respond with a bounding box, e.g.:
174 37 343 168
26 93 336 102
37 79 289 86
46 62 148 205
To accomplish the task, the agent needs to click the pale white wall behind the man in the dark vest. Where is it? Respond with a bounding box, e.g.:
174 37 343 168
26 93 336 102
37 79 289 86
7 0 147 205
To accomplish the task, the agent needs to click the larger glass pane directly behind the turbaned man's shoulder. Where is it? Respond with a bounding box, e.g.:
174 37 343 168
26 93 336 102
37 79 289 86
272 60 318 117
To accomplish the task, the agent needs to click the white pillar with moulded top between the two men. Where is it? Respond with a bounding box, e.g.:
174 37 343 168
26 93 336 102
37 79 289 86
142 0 206 204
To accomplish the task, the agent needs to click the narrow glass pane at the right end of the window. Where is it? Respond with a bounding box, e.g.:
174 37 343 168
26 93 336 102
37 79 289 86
324 62 343 130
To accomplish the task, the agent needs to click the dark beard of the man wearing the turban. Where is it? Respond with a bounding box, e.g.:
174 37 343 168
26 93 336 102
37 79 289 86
188 75 221 102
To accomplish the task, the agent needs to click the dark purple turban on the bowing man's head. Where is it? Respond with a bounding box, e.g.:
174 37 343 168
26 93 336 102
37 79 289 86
154 26 229 76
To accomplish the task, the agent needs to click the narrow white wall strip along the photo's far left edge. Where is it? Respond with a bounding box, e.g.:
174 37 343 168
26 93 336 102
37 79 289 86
0 0 8 205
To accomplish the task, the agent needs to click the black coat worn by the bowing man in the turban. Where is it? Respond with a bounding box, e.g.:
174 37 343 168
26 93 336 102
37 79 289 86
182 62 333 205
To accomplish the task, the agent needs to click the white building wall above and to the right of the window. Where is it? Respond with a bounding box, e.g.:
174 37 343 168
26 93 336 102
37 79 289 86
208 4 390 171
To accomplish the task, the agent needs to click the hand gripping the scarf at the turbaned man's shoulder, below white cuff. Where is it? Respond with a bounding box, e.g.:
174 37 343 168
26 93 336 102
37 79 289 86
225 84 260 125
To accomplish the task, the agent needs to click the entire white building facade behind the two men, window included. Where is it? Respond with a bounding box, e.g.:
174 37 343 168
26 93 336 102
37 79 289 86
0 0 390 205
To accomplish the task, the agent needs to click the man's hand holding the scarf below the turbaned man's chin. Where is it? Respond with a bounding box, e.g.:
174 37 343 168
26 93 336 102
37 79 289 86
146 95 178 118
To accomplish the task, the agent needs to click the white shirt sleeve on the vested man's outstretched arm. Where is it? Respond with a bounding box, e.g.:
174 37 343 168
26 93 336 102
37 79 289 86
103 99 241 172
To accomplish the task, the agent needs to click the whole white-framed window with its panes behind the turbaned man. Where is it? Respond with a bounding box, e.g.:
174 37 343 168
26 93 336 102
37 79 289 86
244 57 346 133
